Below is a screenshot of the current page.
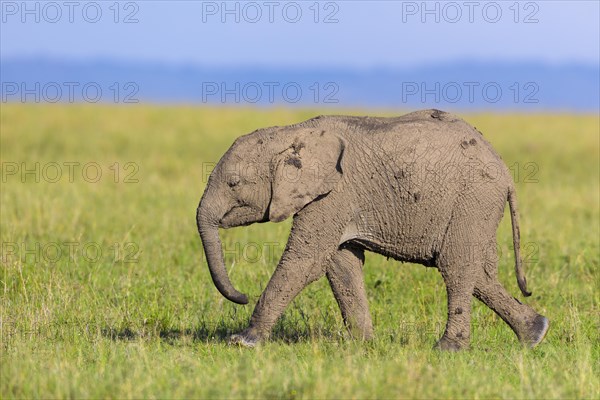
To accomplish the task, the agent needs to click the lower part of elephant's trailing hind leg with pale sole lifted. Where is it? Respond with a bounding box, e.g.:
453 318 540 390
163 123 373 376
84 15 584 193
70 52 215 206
474 268 549 347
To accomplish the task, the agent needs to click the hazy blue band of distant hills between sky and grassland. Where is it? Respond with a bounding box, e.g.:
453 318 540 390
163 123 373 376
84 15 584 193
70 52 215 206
0 58 600 112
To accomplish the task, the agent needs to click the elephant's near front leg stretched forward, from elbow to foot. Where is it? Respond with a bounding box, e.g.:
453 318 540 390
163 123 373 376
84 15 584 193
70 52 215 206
229 244 325 347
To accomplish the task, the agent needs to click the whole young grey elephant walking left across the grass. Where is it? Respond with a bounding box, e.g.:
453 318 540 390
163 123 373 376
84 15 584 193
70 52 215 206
197 110 548 350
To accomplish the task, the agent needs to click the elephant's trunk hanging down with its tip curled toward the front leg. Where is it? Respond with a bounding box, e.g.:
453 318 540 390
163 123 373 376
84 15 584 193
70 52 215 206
196 201 248 304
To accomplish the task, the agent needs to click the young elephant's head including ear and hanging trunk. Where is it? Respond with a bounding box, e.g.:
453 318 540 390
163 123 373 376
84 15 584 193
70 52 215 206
196 127 344 304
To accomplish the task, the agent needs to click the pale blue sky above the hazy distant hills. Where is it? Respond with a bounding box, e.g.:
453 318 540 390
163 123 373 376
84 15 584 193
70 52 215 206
0 0 600 69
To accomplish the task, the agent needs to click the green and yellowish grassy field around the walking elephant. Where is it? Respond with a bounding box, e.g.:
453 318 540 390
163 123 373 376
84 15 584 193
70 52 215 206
0 104 600 399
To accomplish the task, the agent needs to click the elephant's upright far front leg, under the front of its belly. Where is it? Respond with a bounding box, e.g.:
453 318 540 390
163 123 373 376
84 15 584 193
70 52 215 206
327 247 373 340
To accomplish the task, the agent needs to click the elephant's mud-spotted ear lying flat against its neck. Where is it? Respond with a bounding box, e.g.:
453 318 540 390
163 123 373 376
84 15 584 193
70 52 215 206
269 129 345 222
